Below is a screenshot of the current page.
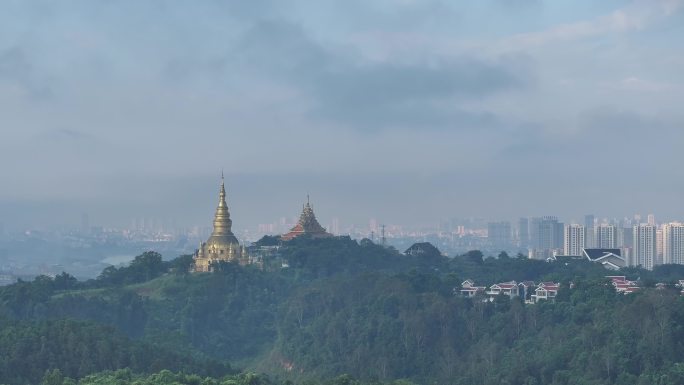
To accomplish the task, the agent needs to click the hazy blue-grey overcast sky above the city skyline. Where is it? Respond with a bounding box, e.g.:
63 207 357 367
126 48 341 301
0 0 684 228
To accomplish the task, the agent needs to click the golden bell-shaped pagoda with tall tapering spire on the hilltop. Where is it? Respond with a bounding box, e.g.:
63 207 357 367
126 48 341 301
194 173 248 271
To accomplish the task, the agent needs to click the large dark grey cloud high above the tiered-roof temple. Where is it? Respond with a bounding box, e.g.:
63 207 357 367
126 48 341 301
233 21 531 128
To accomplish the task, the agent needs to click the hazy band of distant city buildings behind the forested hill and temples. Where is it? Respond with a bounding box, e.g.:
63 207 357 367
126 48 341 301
0 177 684 277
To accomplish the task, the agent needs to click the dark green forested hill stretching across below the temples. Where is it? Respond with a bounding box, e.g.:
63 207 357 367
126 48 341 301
0 234 684 385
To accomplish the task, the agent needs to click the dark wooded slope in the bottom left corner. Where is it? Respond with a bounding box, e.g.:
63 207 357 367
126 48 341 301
0 320 232 384
